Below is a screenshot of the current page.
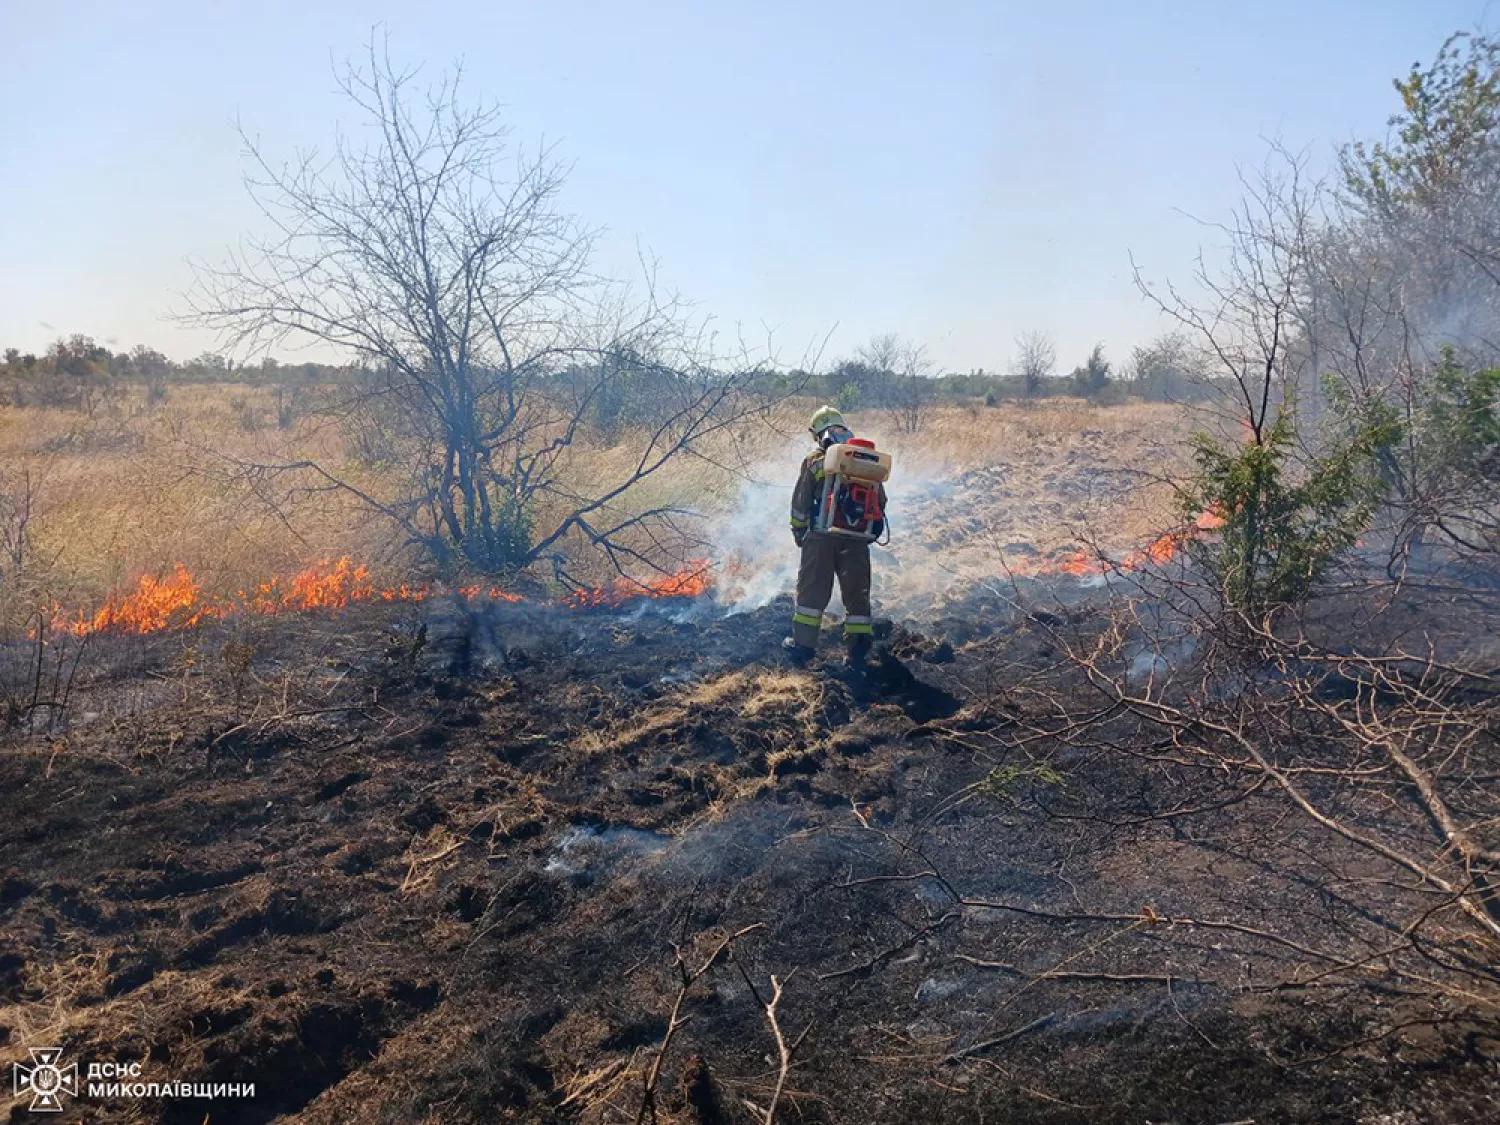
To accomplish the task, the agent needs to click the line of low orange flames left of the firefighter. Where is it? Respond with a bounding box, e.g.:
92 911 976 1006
38 557 711 636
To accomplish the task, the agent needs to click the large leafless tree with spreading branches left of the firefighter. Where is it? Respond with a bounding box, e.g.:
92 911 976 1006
189 42 764 578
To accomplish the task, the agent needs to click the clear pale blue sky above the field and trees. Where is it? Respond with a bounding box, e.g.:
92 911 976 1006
0 0 1500 371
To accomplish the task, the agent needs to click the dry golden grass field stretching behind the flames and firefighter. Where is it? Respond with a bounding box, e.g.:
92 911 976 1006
0 386 1191 618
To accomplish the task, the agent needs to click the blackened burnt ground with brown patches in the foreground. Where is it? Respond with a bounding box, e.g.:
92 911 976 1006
0 600 1500 1125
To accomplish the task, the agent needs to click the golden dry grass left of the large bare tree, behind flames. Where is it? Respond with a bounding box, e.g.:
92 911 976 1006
0 387 389 618
